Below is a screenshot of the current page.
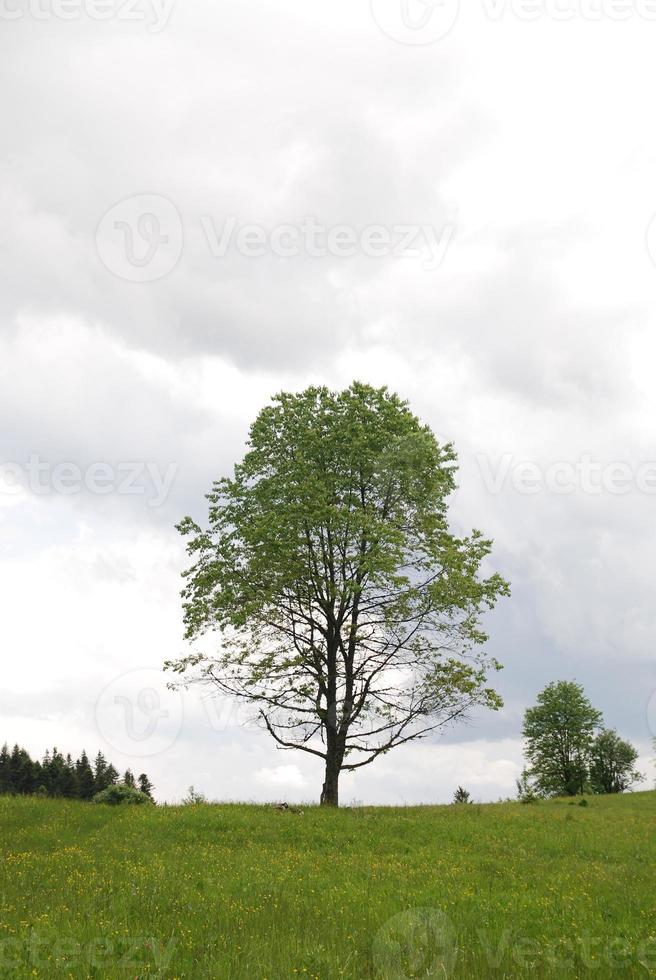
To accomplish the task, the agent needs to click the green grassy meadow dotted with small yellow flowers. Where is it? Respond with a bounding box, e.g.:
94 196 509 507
0 793 656 980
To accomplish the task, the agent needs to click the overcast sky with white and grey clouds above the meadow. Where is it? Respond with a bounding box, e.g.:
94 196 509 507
0 0 656 804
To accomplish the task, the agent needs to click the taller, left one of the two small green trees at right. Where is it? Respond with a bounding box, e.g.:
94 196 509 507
523 681 602 796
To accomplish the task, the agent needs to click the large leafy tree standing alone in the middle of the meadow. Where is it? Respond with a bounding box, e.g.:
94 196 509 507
166 382 509 806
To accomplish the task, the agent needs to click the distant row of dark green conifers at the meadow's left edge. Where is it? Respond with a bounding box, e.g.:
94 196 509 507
0 743 154 800
